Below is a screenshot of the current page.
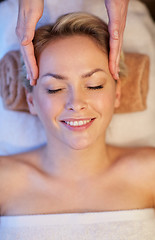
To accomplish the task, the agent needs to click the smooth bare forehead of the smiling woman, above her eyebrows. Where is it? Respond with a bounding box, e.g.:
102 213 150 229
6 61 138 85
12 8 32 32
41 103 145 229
39 35 108 74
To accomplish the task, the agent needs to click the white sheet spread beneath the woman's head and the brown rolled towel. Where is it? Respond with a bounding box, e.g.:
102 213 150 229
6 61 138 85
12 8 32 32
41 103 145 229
0 0 155 155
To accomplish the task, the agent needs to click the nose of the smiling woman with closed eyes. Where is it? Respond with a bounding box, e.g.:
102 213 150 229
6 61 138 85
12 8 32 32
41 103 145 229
66 89 87 112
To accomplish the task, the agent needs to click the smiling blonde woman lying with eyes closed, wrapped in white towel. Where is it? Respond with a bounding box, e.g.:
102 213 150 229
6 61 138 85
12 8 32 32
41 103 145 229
0 13 155 240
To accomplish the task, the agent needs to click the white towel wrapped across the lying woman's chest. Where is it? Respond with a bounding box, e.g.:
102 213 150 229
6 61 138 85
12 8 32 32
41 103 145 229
0 209 155 240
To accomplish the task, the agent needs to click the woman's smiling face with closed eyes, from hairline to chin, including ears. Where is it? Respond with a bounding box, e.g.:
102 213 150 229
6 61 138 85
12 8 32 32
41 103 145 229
28 36 120 149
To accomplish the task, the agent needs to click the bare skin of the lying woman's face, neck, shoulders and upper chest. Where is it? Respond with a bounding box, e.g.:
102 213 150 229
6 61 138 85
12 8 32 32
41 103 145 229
0 36 155 218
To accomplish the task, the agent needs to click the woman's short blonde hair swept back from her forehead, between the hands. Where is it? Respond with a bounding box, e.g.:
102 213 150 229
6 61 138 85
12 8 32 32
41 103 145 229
24 12 124 92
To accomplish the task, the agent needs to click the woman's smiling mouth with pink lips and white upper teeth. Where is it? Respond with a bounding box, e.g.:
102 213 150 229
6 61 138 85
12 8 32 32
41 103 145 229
61 118 95 130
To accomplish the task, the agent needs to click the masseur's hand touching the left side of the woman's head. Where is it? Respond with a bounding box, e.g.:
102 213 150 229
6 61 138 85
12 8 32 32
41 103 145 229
16 0 44 85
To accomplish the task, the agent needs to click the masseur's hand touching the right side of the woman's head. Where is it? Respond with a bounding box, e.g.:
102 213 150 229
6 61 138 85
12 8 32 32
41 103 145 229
105 0 129 80
